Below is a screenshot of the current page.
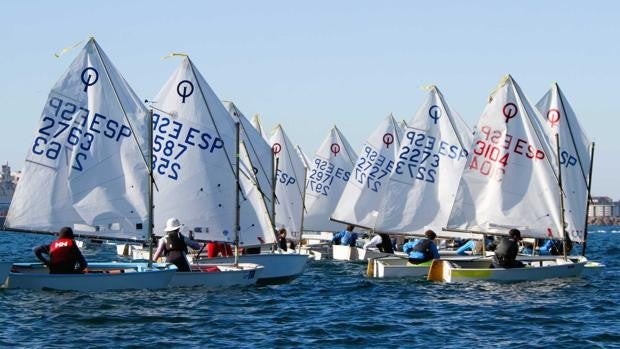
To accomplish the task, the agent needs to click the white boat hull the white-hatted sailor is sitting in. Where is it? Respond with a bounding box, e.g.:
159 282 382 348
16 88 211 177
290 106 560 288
170 263 264 288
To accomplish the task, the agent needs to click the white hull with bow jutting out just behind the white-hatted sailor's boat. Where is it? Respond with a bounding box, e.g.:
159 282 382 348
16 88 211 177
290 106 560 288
197 253 311 284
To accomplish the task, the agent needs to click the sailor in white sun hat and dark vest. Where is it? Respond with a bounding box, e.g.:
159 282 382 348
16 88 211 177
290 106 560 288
153 218 200 271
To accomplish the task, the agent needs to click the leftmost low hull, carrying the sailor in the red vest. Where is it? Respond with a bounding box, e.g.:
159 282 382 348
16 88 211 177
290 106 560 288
6 263 177 292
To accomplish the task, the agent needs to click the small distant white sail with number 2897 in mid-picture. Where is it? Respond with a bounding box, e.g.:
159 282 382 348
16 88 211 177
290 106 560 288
304 126 357 231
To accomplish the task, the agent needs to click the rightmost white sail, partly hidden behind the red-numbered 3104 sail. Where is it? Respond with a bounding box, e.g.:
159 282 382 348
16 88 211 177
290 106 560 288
536 83 592 242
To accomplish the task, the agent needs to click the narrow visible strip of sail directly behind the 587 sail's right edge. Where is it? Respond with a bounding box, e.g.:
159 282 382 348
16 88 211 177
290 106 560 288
223 101 273 216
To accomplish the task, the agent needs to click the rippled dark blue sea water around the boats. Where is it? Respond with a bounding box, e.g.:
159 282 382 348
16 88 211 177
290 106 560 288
0 227 620 348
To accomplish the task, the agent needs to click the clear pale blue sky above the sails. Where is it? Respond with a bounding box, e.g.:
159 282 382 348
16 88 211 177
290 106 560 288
0 1 620 199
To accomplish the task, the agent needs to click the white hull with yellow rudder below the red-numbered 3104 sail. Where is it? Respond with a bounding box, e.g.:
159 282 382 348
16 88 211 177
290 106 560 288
428 258 587 283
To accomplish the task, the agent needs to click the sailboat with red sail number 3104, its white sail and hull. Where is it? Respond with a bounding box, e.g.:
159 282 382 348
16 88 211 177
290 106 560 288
428 75 587 282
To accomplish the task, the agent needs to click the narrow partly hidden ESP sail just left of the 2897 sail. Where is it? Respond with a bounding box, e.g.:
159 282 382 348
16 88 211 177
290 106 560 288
269 125 306 240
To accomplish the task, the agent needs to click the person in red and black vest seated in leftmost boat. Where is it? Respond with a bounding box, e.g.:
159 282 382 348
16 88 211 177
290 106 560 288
33 227 88 274
